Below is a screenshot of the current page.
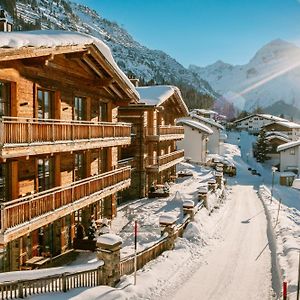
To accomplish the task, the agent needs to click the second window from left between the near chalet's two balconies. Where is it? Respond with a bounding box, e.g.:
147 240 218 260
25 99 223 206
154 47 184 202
37 158 54 192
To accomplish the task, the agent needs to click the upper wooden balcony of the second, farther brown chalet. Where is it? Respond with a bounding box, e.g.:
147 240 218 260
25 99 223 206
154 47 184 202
145 125 184 142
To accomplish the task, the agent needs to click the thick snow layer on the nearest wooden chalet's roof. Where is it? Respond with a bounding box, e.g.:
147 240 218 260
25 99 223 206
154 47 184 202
0 30 139 98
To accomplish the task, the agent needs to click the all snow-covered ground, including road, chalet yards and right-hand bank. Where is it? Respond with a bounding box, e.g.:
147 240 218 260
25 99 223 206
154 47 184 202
8 133 300 300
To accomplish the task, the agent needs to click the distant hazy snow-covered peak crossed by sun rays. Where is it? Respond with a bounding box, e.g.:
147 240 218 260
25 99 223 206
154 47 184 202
189 39 300 118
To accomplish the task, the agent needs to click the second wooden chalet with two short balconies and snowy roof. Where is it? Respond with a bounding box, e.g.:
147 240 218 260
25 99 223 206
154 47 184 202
119 86 188 198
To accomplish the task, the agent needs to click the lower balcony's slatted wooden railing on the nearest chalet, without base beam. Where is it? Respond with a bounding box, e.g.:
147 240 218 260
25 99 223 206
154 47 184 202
1 167 130 232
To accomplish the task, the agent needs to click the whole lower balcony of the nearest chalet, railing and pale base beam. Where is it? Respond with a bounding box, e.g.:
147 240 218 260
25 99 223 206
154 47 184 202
0 167 131 244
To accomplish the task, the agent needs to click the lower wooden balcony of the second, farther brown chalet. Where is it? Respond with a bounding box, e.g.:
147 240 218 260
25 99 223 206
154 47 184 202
147 150 184 173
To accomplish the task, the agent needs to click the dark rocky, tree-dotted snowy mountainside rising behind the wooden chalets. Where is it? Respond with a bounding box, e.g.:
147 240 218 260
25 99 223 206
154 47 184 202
0 0 216 107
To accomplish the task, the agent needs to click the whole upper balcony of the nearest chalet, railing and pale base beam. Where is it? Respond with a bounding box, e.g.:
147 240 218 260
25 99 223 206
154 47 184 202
0 117 131 159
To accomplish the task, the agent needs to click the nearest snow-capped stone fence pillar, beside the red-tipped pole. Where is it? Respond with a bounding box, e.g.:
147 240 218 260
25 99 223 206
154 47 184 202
97 233 122 287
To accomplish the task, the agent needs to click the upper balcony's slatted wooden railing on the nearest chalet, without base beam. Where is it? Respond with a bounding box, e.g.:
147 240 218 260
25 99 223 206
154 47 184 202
0 117 131 145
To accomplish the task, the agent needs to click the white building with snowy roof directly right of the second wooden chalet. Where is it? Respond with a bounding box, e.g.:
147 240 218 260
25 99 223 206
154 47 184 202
177 119 214 164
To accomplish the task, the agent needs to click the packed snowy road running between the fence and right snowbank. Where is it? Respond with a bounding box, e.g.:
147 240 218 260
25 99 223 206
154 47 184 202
172 158 271 300
